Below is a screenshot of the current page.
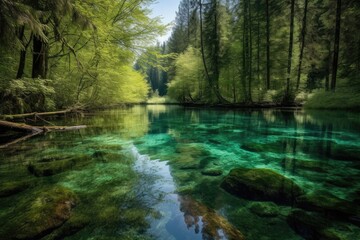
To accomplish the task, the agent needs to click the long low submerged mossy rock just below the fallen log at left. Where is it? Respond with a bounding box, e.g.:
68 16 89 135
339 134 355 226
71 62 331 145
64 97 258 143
28 156 90 177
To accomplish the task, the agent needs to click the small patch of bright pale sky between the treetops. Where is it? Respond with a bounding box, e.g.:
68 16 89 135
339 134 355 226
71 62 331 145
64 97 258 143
151 0 180 42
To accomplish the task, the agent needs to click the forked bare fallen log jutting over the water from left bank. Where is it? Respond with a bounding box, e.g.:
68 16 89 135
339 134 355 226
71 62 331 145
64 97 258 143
0 121 86 149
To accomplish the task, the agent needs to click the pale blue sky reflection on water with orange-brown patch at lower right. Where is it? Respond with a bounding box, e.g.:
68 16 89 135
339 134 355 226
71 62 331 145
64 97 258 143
131 146 243 240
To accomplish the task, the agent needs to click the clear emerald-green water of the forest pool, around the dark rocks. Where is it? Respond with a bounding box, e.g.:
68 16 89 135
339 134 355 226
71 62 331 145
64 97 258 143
0 106 360 240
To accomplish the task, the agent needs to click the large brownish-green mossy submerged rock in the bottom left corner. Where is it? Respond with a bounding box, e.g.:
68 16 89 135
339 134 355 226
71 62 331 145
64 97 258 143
0 186 78 239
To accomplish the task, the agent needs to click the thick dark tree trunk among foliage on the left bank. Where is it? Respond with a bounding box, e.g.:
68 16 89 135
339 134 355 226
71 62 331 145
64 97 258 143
32 36 48 79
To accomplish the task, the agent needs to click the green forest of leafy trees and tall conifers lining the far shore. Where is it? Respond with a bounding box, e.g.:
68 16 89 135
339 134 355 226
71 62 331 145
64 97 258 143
0 0 360 114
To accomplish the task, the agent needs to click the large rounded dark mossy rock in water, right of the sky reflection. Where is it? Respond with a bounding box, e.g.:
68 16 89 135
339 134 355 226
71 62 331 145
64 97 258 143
221 168 303 205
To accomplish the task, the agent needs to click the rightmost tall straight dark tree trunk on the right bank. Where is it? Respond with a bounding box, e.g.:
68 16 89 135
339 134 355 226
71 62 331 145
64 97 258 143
330 0 341 92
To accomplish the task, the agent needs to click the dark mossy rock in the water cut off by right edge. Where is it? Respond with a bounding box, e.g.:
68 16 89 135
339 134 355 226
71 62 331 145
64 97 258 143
297 191 360 225
